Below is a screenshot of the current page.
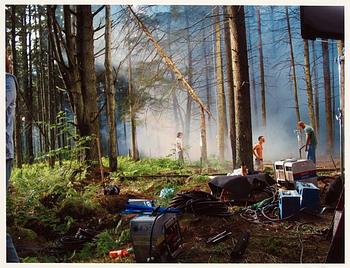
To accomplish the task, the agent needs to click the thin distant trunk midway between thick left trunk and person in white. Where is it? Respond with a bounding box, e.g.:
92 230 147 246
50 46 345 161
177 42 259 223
128 43 140 161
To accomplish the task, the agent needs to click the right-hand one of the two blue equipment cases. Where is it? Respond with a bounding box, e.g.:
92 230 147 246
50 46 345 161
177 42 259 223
295 181 320 211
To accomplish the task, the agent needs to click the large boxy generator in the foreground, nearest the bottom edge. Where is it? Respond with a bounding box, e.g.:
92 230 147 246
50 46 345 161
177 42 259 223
130 213 182 263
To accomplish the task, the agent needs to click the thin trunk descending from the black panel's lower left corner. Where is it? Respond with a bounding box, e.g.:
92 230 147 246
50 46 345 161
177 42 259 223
304 39 316 129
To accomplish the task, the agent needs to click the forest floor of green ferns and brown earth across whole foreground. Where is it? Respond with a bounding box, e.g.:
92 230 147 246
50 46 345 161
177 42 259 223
7 158 337 263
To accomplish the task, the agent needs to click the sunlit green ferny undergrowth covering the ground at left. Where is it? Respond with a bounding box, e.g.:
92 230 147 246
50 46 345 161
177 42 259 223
6 157 216 262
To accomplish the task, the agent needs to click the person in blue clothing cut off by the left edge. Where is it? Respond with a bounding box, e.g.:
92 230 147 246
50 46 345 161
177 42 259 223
6 50 19 262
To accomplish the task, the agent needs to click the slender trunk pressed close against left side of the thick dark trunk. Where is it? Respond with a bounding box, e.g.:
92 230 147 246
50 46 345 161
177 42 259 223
224 6 236 167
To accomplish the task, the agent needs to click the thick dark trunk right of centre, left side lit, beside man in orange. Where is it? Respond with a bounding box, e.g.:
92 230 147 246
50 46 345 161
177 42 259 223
228 6 253 170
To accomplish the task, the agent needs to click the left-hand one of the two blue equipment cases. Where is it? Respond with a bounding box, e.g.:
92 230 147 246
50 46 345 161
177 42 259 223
278 190 300 219
